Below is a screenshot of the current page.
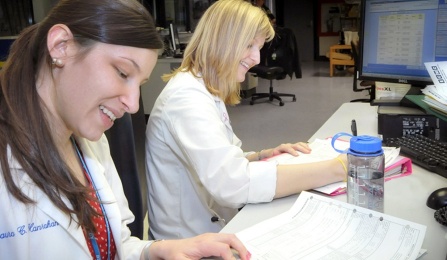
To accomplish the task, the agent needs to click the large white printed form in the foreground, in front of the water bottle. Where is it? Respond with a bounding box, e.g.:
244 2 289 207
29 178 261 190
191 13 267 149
236 191 426 260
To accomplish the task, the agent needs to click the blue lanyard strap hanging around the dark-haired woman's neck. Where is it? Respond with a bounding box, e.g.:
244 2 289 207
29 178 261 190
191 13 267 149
70 136 111 260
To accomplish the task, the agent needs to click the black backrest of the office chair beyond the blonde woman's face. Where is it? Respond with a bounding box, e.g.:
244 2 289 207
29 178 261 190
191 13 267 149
260 27 302 79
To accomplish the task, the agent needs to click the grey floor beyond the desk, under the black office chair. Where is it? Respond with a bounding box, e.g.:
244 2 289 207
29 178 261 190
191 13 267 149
228 61 368 151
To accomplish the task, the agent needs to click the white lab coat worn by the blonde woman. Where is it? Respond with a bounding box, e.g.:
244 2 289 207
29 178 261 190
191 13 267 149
146 72 276 239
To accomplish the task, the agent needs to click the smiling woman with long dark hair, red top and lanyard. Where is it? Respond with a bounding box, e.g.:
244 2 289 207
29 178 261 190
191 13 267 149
0 0 249 259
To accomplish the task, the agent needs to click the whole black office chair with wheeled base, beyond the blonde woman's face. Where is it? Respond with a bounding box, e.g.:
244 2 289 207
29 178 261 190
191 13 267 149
249 27 302 106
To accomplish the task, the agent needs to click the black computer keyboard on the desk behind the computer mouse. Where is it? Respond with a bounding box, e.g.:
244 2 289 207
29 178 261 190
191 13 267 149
383 135 447 178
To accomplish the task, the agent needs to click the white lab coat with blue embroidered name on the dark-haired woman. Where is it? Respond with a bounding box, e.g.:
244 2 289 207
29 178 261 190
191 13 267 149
0 135 149 260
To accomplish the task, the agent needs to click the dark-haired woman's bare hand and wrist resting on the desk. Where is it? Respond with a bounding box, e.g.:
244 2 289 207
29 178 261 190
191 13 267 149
148 233 251 260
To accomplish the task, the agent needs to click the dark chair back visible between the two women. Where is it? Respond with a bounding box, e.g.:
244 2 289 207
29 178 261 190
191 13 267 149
105 94 147 239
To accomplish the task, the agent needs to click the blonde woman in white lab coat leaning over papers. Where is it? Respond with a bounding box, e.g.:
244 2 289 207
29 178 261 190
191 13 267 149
146 0 346 239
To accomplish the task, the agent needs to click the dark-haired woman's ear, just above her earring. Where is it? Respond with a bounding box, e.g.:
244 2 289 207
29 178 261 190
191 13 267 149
47 24 73 60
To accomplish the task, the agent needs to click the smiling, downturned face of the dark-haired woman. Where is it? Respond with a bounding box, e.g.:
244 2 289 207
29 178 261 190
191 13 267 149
51 43 158 140
